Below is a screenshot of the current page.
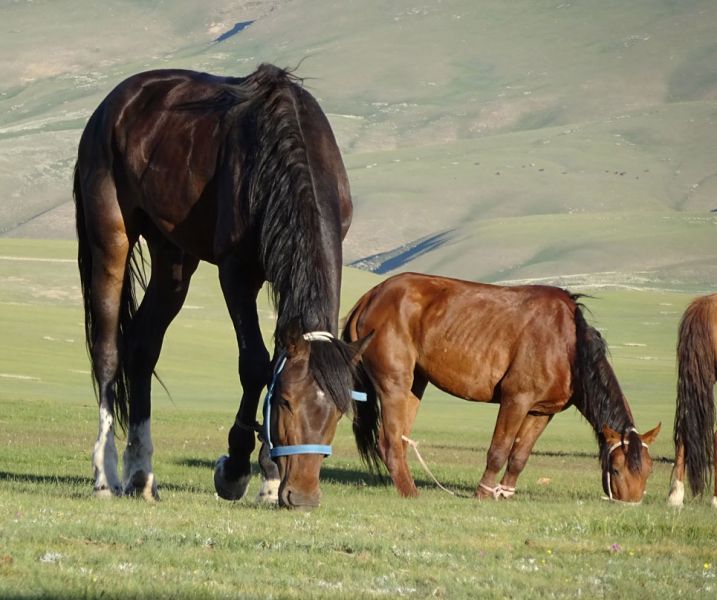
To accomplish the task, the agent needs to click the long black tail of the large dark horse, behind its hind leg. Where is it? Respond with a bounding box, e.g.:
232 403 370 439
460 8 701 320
73 165 146 430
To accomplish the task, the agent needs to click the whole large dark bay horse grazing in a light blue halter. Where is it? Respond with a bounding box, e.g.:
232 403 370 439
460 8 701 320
74 65 370 506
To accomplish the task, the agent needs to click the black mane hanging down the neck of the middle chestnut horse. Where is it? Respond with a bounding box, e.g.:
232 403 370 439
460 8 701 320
574 296 642 472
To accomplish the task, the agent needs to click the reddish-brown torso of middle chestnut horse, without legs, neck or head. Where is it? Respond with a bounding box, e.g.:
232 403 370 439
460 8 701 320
346 273 576 412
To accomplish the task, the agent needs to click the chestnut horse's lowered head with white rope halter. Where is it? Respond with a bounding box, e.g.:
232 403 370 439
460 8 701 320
602 423 662 503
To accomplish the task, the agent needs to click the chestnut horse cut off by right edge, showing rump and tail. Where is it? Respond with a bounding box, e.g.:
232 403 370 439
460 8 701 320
667 294 717 508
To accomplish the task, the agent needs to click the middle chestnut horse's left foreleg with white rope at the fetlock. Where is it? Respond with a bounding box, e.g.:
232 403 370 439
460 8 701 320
475 396 528 500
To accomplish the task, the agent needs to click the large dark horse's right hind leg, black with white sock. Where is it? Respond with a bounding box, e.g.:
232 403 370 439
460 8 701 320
123 242 199 501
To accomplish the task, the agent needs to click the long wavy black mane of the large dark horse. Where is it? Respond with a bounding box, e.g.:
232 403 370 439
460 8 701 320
240 65 341 338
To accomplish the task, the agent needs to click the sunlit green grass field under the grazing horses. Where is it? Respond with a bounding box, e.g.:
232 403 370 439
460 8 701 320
0 239 717 598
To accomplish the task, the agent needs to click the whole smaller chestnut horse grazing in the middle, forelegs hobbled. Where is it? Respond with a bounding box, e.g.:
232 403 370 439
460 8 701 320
343 273 660 502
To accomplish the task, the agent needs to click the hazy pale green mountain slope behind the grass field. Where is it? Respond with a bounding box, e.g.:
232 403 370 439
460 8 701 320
0 0 717 289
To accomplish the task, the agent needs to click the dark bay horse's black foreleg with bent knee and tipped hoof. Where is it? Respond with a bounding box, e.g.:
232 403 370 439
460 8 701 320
214 256 270 501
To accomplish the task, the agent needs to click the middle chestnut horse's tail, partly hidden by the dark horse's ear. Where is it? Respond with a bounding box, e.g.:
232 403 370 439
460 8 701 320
341 294 383 474
